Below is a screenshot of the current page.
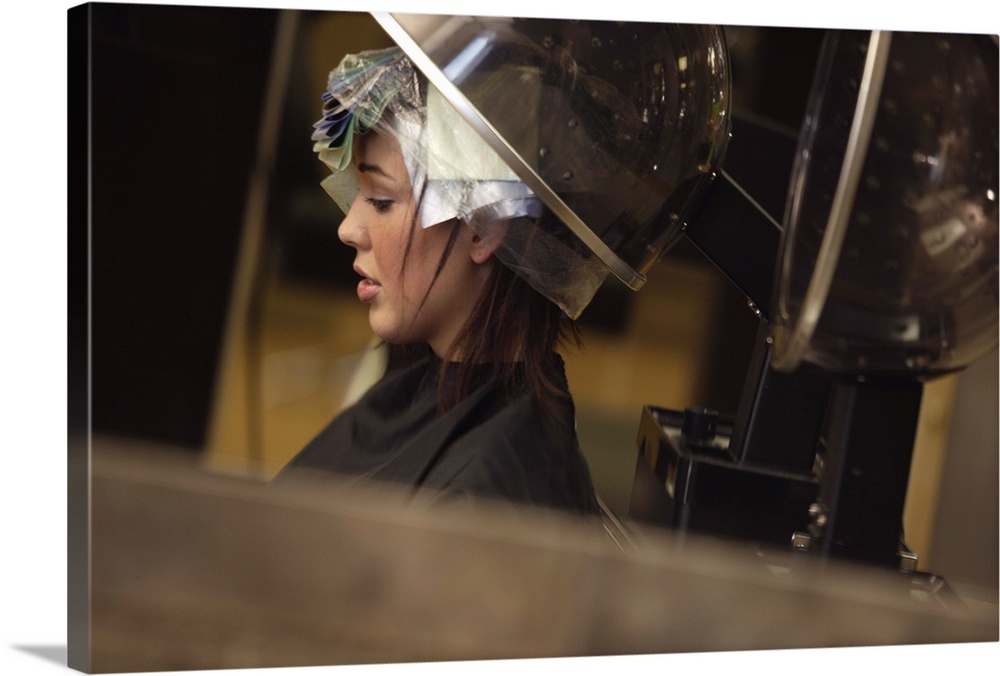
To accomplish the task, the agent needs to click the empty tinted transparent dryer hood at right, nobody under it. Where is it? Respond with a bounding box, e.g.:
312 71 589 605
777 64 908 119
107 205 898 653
772 31 998 378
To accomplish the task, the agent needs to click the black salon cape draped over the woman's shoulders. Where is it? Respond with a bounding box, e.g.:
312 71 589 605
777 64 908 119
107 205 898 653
279 350 598 514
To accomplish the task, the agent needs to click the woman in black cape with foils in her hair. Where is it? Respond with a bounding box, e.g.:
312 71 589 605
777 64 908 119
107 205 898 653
280 49 601 513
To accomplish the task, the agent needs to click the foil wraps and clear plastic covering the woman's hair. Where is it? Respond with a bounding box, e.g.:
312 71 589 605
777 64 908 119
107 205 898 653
313 48 607 318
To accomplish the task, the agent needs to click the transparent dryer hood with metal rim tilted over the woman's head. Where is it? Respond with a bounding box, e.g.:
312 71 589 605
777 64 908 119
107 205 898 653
373 13 729 289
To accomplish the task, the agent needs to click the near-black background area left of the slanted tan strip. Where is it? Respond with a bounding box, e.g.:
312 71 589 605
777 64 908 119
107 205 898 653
85 4 278 448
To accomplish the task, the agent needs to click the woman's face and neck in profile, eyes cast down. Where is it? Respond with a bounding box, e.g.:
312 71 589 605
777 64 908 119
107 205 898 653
337 132 487 357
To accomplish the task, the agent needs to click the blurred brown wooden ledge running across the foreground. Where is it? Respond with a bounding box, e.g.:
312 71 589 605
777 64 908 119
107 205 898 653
90 438 998 672
